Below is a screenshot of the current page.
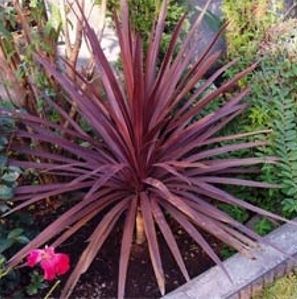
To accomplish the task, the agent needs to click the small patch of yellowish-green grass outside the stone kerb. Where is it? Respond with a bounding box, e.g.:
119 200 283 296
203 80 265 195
253 273 297 299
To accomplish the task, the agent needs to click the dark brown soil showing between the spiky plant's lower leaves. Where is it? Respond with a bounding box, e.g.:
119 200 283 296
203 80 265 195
55 218 221 299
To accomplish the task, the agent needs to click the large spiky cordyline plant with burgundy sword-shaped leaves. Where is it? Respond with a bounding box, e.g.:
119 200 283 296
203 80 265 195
2 0 292 298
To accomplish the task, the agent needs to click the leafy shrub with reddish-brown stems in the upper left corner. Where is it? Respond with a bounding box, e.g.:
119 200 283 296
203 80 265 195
0 1 61 115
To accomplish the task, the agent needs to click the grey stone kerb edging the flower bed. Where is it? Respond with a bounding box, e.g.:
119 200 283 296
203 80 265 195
163 220 297 299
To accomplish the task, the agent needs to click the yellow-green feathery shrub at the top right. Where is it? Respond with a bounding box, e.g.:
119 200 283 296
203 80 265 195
222 0 282 81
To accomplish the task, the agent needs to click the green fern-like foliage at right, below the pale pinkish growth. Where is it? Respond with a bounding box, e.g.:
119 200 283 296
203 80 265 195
248 56 297 217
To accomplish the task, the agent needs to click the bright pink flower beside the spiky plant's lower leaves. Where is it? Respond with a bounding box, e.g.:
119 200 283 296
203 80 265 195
27 246 70 280
